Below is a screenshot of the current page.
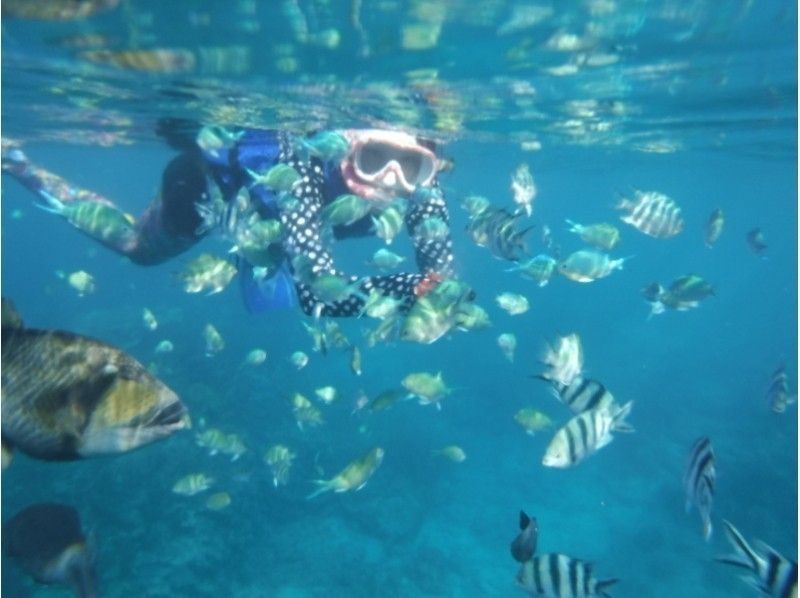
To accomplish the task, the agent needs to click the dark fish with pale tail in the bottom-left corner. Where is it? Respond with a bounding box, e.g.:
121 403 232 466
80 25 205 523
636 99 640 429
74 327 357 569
3 503 97 598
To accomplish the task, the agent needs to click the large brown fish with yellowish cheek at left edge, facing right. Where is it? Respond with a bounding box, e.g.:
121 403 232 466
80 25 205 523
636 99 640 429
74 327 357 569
0 301 189 461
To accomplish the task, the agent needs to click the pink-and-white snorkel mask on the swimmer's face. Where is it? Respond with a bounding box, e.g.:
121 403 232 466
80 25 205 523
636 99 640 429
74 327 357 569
341 129 438 200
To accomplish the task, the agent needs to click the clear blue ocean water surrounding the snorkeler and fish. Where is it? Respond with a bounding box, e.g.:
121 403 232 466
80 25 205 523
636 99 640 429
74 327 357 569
2 0 798 597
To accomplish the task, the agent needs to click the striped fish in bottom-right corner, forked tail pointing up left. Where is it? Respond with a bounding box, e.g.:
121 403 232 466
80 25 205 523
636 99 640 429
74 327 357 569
716 520 797 598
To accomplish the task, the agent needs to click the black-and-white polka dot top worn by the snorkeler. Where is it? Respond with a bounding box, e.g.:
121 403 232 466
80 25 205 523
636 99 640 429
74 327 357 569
216 133 454 316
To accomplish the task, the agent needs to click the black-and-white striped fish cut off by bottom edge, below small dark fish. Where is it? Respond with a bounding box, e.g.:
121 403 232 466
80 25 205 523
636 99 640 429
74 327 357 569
517 552 619 598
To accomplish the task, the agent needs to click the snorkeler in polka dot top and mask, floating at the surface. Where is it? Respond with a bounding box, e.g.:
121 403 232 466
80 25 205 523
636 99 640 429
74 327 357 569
2 119 462 316
